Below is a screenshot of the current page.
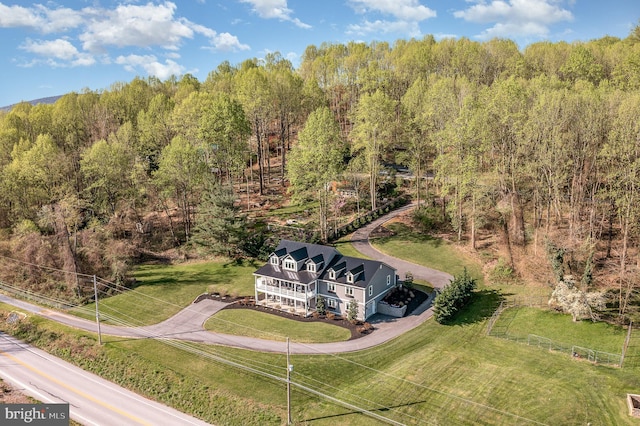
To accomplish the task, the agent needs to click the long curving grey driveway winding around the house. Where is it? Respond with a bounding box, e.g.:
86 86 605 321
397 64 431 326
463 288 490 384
0 204 453 354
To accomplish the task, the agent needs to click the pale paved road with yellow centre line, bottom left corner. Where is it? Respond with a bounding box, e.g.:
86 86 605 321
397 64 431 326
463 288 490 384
0 333 208 426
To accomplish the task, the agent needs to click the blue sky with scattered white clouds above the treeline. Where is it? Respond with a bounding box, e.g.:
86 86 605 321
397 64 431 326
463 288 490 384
0 0 640 106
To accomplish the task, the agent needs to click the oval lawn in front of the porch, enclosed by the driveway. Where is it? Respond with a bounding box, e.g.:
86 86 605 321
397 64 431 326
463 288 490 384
205 309 351 343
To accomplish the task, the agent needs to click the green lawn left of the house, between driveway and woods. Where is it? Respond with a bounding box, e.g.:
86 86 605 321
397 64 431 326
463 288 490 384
75 261 261 325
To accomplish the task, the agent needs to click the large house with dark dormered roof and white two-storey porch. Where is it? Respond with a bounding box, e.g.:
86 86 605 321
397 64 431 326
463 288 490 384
253 240 397 320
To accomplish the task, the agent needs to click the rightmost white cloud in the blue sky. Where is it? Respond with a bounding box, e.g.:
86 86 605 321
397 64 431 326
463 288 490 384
453 0 573 39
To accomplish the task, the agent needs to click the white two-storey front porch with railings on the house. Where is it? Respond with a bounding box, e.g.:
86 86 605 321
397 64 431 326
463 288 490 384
256 277 316 317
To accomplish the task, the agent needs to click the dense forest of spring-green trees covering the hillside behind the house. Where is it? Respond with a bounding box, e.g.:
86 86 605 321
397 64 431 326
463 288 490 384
0 27 640 314
